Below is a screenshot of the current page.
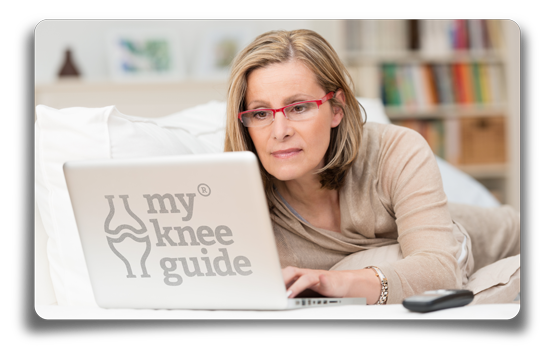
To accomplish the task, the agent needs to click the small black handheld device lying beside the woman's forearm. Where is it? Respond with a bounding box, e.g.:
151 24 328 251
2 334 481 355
403 290 474 313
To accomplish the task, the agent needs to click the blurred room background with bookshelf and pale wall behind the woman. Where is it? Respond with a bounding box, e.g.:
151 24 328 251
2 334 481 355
35 19 520 210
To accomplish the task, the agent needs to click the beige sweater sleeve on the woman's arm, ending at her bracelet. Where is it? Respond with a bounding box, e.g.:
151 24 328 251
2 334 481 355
375 125 462 303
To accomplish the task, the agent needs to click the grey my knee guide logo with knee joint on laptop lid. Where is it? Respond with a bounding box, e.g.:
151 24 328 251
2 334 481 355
103 183 252 286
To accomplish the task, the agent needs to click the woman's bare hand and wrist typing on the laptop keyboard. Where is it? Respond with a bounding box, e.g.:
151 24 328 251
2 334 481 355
283 266 381 304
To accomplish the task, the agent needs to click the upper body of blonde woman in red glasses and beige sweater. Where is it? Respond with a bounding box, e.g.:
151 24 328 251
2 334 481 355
225 30 519 304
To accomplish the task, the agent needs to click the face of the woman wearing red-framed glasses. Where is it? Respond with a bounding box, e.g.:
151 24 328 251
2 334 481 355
245 61 344 181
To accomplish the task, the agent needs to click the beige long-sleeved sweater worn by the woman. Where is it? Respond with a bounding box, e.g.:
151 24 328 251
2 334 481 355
267 123 473 303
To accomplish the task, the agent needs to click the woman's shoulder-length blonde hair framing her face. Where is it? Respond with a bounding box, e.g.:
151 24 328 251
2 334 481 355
224 30 366 190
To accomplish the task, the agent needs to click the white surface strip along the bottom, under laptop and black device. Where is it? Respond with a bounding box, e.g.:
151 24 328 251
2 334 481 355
35 303 520 319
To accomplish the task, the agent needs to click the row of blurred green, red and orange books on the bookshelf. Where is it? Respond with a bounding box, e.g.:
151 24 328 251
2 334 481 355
379 62 503 110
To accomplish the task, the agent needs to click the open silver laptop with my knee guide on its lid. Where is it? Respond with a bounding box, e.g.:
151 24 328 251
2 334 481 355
63 152 366 310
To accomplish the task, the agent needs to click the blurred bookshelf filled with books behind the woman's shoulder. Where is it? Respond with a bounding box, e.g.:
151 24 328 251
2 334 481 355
338 20 519 209
